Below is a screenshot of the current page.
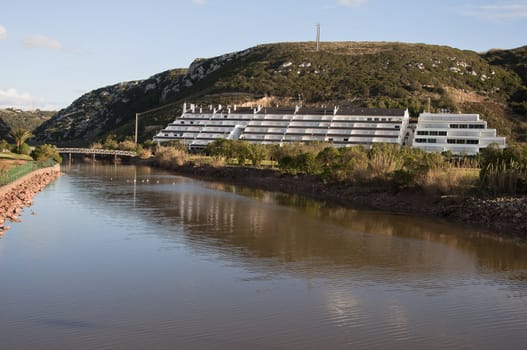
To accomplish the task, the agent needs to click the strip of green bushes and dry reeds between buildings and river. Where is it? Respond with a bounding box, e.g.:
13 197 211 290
151 139 527 195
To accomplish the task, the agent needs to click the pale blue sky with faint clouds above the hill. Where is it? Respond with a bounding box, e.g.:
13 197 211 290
0 0 527 109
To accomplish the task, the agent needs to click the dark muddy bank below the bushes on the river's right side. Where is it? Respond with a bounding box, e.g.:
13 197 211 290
167 165 527 241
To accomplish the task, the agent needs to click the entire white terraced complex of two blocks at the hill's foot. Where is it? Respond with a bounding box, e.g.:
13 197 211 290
154 103 506 155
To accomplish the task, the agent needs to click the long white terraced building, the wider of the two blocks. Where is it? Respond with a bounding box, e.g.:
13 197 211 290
154 104 409 149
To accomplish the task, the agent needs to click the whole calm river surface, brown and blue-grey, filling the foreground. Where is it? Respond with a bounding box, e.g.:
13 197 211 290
0 165 527 350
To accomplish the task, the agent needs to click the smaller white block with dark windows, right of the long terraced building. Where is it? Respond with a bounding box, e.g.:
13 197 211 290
412 113 506 155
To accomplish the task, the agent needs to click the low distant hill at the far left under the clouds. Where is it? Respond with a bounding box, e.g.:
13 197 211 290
0 108 56 140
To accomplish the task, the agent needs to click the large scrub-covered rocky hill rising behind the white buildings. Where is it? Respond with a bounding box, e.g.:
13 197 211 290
36 42 527 145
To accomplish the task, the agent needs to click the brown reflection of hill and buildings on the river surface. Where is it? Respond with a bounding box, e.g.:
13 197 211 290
65 167 527 276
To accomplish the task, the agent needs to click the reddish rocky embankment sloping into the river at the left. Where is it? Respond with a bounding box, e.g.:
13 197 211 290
0 165 61 236
